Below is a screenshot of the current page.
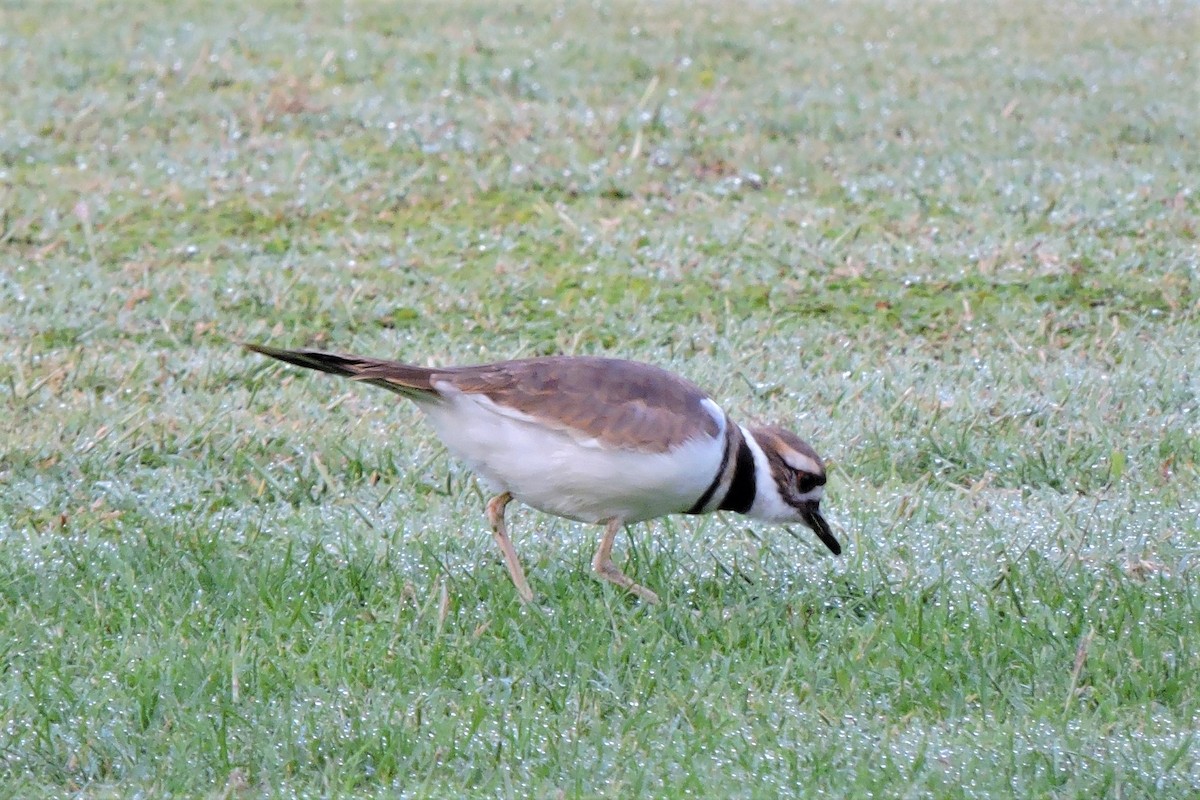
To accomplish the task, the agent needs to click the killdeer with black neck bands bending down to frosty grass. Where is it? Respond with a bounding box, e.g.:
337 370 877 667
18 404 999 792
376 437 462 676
245 344 841 603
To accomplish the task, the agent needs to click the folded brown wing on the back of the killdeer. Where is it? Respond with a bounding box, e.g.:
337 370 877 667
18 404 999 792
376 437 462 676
441 356 720 452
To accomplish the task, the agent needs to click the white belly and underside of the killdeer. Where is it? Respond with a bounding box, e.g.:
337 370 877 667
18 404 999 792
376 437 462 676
421 391 725 523
